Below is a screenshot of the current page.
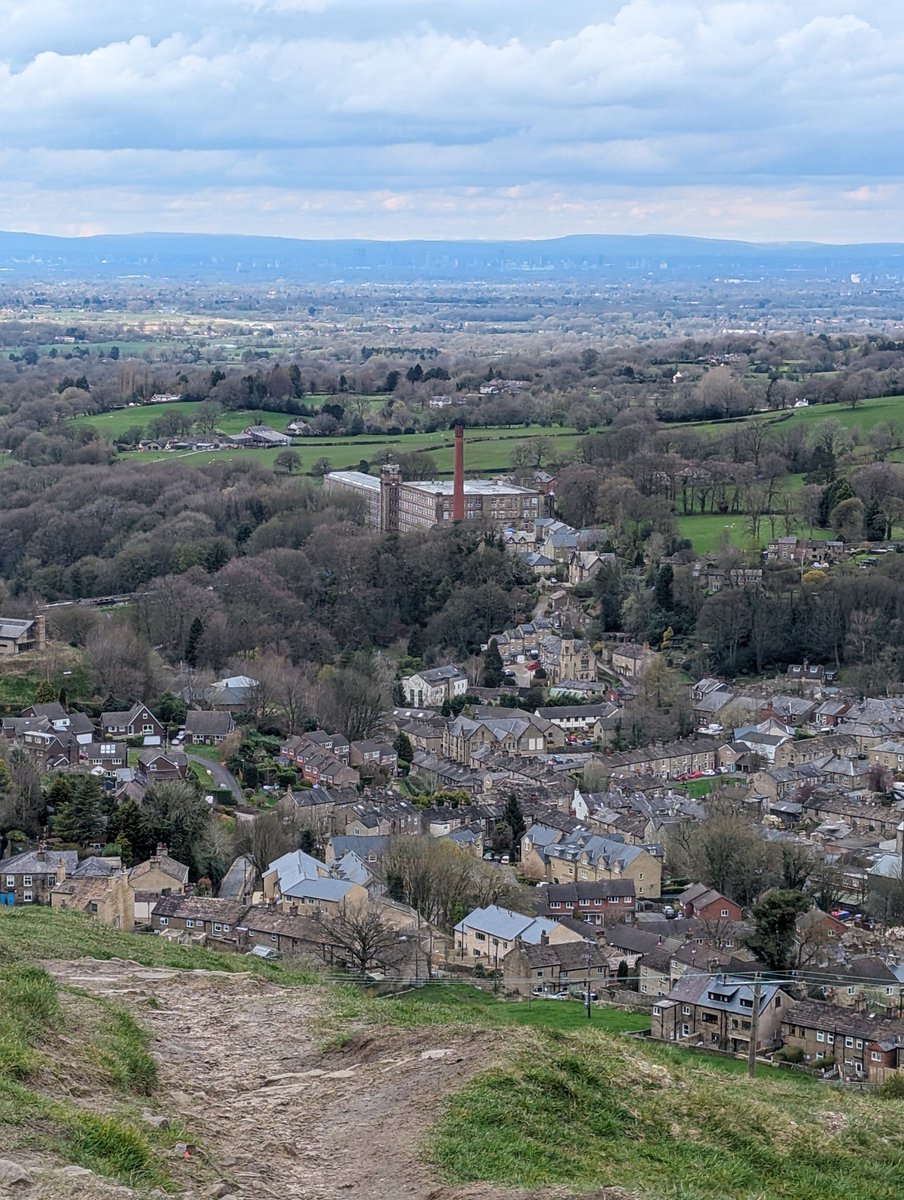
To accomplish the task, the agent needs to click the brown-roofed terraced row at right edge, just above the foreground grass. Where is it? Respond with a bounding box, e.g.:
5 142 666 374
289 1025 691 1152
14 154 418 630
782 1000 904 1082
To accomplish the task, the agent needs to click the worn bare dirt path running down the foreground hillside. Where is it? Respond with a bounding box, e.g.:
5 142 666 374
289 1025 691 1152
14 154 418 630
47 960 619 1200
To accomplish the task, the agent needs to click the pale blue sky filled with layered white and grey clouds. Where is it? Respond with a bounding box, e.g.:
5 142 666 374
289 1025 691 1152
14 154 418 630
0 0 904 242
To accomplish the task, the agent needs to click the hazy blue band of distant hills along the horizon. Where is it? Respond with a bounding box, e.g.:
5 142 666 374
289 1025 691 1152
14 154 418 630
0 232 904 283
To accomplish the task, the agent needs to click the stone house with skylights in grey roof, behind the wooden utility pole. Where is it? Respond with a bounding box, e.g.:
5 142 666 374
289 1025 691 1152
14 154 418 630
651 973 789 1054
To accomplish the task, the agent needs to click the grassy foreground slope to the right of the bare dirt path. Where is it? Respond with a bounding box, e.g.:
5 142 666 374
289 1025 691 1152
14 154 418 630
426 1031 904 1200
